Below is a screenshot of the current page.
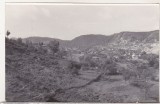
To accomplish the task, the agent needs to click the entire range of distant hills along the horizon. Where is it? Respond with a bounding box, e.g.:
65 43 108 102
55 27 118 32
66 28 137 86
23 30 159 49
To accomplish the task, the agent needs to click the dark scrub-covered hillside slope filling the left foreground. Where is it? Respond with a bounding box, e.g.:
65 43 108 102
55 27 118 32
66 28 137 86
6 38 72 101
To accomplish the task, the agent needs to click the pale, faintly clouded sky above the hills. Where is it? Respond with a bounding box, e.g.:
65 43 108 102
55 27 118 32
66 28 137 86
5 4 159 40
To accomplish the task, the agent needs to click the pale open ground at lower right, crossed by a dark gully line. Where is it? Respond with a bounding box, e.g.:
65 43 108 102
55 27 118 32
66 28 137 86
52 70 158 102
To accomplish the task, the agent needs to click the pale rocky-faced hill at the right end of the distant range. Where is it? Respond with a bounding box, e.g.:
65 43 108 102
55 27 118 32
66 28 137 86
110 30 159 44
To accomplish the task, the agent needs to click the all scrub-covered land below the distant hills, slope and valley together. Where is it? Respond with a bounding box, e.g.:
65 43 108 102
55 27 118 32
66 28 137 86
6 29 159 103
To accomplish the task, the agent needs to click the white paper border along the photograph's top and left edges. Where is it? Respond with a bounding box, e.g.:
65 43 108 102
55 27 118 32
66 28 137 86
0 0 160 104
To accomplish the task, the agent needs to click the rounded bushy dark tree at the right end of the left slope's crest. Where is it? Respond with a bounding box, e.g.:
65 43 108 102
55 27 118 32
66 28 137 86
48 40 59 54
